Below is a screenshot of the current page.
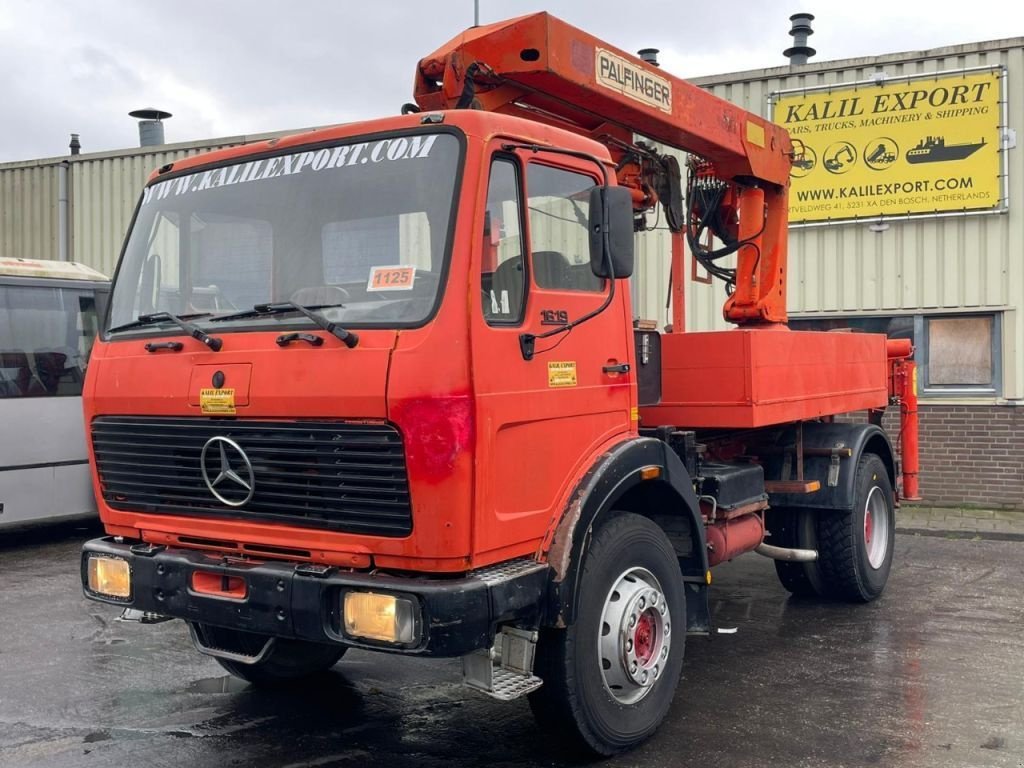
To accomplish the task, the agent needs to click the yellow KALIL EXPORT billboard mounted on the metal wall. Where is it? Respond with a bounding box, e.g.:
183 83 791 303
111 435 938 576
770 69 1006 224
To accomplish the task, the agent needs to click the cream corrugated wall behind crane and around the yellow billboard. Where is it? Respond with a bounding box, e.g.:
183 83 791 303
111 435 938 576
636 38 1024 398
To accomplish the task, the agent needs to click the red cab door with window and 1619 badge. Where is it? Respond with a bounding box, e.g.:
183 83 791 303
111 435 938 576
470 152 636 559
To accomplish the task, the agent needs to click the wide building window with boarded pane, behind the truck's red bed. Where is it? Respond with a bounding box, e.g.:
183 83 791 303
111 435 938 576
790 313 1002 397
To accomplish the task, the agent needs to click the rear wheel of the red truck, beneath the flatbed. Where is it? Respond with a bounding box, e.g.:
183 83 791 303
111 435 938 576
817 454 896 602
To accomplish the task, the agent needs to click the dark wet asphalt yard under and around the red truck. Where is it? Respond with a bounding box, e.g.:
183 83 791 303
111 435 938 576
0 527 1024 768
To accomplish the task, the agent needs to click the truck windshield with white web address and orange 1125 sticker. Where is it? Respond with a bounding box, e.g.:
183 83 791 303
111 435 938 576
110 133 460 333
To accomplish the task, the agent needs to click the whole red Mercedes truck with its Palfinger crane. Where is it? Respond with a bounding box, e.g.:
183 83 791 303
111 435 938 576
81 13 915 755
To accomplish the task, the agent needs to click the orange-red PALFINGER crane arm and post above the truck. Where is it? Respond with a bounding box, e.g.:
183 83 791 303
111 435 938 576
414 12 793 330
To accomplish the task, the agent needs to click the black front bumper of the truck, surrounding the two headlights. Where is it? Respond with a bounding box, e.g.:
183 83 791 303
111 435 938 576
82 537 549 656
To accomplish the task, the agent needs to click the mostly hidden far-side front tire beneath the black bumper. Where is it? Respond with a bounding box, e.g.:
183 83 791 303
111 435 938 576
199 624 348 687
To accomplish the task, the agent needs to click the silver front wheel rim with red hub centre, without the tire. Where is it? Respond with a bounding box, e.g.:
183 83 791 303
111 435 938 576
598 568 672 703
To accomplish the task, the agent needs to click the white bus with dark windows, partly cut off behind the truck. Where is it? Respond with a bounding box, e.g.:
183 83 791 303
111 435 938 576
0 257 110 530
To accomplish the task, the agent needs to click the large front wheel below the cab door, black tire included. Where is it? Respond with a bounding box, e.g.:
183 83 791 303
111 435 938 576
529 513 686 755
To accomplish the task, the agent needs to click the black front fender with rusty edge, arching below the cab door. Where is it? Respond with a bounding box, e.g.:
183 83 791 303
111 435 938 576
545 437 708 627
